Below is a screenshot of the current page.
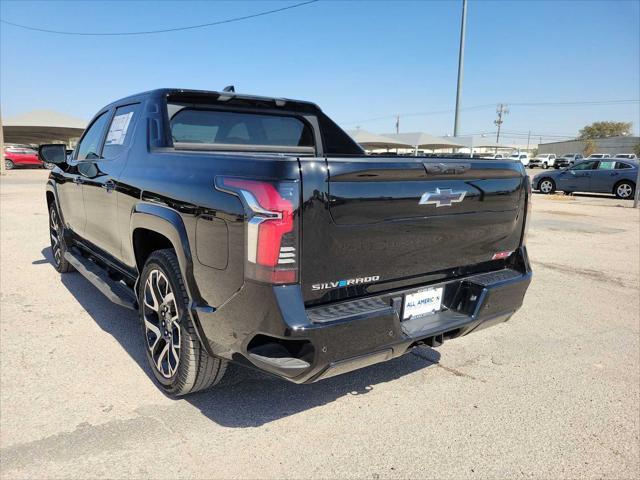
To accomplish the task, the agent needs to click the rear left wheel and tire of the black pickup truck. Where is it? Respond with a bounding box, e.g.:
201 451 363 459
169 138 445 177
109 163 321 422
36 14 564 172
138 249 227 396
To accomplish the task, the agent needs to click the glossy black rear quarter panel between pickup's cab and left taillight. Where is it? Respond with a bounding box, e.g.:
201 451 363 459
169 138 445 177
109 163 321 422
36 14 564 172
117 131 300 307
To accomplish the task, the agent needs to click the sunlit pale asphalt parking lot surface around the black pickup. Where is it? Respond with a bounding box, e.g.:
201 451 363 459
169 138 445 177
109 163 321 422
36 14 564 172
0 169 640 479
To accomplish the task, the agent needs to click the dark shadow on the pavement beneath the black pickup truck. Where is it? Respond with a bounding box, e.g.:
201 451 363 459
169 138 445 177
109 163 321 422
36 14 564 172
38 248 440 428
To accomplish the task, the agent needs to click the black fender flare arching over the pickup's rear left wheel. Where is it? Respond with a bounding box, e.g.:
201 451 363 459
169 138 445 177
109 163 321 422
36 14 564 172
129 201 214 355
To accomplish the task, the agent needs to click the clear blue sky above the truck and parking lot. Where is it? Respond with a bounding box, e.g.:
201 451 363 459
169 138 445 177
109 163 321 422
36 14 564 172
0 0 640 142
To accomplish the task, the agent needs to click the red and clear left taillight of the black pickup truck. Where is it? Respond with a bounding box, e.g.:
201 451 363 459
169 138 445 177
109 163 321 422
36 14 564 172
216 177 300 284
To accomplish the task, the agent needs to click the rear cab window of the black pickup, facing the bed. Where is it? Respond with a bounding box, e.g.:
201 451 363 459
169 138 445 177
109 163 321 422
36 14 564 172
170 108 314 147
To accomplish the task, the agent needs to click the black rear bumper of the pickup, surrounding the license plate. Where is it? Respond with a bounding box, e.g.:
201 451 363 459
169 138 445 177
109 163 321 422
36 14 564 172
195 248 532 383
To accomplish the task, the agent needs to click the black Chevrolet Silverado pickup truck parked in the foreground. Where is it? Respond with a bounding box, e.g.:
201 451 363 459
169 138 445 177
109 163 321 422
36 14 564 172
40 89 531 395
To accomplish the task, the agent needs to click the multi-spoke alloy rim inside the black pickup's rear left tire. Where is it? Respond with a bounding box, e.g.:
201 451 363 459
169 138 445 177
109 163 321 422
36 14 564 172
142 269 181 379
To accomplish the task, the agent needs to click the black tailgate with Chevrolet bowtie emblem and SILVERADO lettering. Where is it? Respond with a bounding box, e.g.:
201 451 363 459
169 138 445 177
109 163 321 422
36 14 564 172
301 157 525 304
